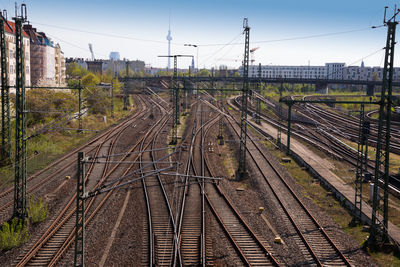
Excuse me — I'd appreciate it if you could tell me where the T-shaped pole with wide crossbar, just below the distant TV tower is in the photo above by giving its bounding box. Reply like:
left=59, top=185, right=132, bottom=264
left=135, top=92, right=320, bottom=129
left=158, top=55, right=193, bottom=145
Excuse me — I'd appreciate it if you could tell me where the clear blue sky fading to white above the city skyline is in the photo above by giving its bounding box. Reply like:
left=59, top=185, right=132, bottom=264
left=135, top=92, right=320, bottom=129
left=0, top=0, right=400, bottom=68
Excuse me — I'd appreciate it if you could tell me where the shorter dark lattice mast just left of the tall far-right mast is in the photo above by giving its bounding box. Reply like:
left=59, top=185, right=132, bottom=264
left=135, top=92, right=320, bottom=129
left=351, top=104, right=369, bottom=225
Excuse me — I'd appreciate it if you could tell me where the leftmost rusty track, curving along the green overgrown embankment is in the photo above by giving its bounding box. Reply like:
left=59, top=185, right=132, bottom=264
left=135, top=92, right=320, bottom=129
left=0, top=96, right=146, bottom=221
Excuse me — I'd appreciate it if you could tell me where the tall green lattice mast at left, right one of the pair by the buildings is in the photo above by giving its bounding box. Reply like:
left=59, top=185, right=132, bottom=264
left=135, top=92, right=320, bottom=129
left=13, top=4, right=27, bottom=220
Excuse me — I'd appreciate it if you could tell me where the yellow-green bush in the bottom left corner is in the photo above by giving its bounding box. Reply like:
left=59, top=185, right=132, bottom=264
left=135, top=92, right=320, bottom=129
left=0, top=218, right=29, bottom=250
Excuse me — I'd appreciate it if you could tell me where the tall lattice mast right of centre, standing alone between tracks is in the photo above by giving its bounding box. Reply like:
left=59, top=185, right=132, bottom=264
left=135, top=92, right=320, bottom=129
left=236, top=18, right=250, bottom=180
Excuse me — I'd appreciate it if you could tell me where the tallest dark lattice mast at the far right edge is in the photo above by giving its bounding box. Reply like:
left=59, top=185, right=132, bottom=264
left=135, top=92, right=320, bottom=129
left=369, top=8, right=399, bottom=245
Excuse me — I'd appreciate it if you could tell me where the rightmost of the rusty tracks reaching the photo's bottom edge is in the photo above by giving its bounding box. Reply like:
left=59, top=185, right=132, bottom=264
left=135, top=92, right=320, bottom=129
left=223, top=103, right=351, bottom=266
